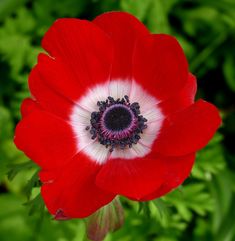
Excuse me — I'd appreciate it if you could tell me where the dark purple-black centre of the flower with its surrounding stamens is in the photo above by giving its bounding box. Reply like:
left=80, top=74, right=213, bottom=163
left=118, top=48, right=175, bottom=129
left=86, top=95, right=147, bottom=152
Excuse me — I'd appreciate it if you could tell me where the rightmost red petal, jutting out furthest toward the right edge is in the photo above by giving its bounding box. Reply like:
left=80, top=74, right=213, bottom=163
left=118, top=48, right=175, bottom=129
left=153, top=100, right=221, bottom=156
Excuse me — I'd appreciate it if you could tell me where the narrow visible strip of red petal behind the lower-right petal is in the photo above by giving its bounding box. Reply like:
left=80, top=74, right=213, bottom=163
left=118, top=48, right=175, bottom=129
left=141, top=154, right=195, bottom=201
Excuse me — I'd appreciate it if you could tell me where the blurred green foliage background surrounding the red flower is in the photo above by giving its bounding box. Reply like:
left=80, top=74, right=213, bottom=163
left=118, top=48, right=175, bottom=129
left=0, top=0, right=235, bottom=241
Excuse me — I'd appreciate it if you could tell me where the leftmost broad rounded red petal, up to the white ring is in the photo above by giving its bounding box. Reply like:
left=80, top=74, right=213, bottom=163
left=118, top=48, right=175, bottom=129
left=14, top=111, right=77, bottom=169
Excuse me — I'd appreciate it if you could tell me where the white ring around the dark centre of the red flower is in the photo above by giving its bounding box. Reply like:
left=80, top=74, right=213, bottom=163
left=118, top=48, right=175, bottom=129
left=70, top=79, right=164, bottom=164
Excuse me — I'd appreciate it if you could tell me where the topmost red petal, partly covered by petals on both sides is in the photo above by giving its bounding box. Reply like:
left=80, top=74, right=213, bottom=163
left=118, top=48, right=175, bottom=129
left=93, top=12, right=149, bottom=79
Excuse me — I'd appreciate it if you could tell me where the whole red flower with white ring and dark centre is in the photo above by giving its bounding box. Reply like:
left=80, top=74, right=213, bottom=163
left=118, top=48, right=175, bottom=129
left=15, top=12, right=221, bottom=219
